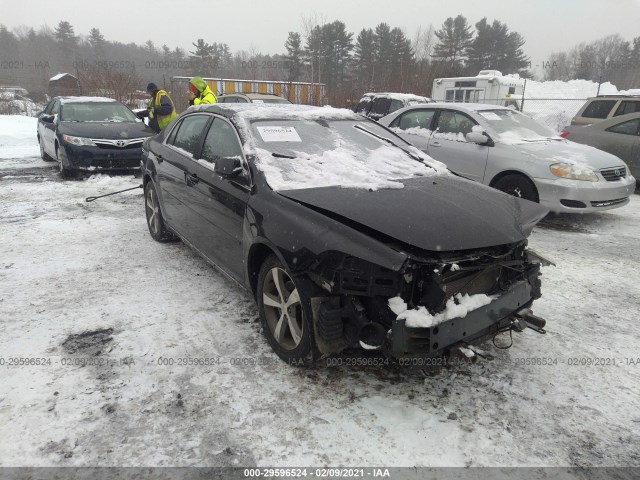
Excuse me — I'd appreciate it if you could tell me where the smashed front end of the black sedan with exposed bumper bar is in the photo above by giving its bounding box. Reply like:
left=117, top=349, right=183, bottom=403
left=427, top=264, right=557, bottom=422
left=308, top=240, right=547, bottom=358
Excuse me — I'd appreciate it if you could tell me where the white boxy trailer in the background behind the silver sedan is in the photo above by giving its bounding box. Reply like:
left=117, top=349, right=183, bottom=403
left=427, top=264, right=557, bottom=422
left=431, top=70, right=525, bottom=110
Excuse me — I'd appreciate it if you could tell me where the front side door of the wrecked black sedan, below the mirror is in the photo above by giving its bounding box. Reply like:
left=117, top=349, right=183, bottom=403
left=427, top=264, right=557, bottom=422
left=187, top=117, right=251, bottom=281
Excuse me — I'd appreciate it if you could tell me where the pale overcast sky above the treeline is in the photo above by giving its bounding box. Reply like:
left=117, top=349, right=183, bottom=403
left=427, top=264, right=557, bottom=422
left=0, top=0, right=640, bottom=70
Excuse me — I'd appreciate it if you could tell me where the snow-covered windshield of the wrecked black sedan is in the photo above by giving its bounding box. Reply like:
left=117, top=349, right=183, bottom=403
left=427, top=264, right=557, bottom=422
left=251, top=119, right=446, bottom=190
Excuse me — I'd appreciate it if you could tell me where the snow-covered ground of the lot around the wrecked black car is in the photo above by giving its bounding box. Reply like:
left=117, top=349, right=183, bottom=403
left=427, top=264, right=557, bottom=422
left=0, top=116, right=640, bottom=466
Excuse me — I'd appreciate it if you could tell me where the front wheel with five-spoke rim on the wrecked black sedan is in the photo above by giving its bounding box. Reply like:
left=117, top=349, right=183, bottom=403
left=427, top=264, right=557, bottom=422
left=258, top=255, right=315, bottom=366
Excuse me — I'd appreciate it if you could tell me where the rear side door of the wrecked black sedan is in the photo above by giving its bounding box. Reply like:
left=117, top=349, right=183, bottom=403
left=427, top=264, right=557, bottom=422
left=152, top=113, right=212, bottom=241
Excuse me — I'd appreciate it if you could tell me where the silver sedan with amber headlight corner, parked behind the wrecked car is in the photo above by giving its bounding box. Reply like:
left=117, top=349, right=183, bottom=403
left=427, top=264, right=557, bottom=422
left=379, top=103, right=636, bottom=213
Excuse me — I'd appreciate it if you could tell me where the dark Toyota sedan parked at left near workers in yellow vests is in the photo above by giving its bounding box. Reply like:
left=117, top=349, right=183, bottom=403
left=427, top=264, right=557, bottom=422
left=38, top=97, right=155, bottom=176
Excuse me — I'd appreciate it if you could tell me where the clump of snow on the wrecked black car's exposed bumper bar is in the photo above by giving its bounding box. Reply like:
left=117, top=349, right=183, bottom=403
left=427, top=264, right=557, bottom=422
left=389, top=293, right=497, bottom=328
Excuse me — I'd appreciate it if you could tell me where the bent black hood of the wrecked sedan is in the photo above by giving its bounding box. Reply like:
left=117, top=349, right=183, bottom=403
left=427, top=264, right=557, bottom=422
left=278, top=176, right=548, bottom=252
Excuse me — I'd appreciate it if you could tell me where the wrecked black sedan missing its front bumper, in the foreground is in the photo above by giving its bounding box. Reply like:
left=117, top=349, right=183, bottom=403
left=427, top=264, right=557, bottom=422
left=142, top=104, right=547, bottom=364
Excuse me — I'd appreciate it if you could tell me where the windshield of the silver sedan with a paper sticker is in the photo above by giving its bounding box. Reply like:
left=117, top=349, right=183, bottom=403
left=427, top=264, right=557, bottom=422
left=478, top=110, right=562, bottom=143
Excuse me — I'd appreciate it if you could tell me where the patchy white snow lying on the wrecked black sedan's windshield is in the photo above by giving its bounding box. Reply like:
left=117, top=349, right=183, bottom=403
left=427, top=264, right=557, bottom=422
left=254, top=145, right=443, bottom=190
